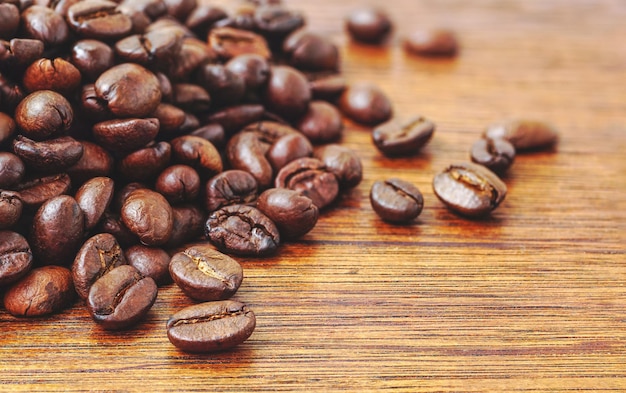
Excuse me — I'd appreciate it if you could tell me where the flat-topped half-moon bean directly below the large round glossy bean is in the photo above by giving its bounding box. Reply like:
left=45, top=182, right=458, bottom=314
left=92, top=117, right=160, bottom=152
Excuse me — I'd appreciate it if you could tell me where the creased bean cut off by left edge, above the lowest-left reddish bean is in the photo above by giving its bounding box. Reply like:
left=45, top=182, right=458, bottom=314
left=0, top=230, right=33, bottom=287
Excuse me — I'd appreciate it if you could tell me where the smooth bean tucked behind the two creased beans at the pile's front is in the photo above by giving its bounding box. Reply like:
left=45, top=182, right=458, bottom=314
left=124, top=244, right=172, bottom=285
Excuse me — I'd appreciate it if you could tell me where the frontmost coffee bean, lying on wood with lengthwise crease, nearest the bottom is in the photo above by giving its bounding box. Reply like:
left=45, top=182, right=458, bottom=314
left=166, top=300, right=256, bottom=353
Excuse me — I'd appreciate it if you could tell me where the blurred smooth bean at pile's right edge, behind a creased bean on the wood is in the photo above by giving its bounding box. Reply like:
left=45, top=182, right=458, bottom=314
left=338, top=82, right=393, bottom=125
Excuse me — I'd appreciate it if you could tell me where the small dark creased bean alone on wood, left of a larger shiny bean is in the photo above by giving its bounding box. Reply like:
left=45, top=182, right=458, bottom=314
left=370, top=178, right=424, bottom=223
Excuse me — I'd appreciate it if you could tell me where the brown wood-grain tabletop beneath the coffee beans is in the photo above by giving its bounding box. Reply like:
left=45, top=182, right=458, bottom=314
left=0, top=0, right=626, bottom=392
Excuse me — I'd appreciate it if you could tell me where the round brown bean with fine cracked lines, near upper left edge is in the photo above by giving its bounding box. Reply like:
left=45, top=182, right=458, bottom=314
left=15, top=90, right=74, bottom=141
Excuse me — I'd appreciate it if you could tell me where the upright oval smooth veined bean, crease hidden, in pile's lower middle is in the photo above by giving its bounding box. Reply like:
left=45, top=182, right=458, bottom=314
left=121, top=189, right=174, bottom=246
